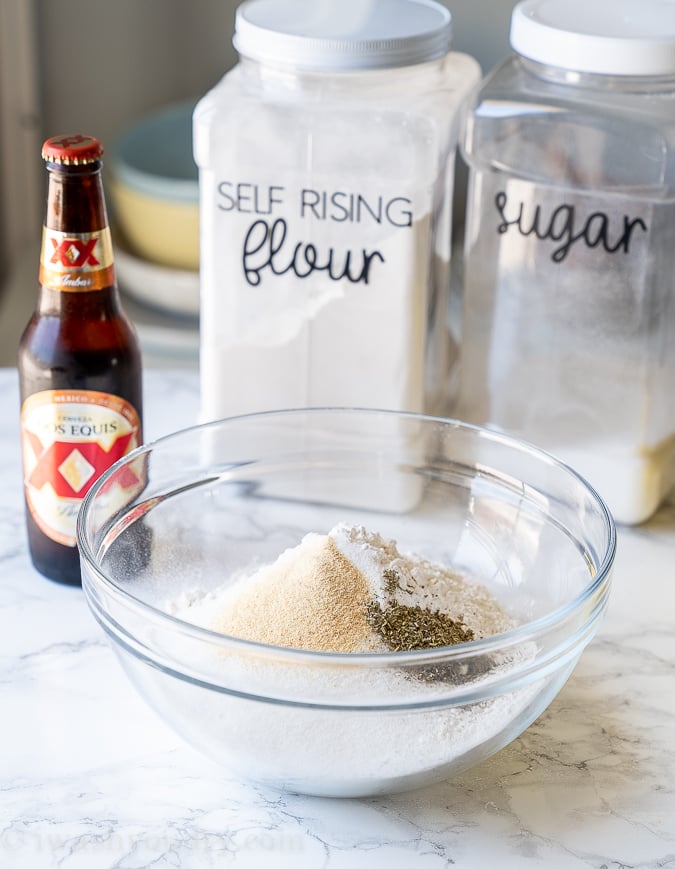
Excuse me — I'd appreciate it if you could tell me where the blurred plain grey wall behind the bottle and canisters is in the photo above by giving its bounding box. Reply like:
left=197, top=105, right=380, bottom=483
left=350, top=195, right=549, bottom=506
left=0, top=0, right=515, bottom=286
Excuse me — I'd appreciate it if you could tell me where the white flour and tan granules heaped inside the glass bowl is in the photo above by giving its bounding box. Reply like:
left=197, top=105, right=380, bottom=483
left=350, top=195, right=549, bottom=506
left=169, top=525, right=544, bottom=796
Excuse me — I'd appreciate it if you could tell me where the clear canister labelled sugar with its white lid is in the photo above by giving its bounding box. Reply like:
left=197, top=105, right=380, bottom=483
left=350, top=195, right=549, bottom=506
left=462, top=0, right=675, bottom=524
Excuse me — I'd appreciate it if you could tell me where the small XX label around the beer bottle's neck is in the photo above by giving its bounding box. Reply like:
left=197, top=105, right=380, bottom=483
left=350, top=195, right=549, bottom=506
left=39, top=226, right=115, bottom=293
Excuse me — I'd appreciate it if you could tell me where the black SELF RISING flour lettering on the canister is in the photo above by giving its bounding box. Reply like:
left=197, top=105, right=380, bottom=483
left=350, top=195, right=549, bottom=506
left=217, top=181, right=413, bottom=287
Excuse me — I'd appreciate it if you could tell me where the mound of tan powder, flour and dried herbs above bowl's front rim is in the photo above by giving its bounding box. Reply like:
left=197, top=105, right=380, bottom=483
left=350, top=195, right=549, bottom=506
left=172, top=523, right=514, bottom=652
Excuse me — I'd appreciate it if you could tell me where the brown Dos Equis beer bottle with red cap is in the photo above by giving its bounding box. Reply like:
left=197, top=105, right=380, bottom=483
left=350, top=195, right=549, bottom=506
left=18, top=135, right=142, bottom=585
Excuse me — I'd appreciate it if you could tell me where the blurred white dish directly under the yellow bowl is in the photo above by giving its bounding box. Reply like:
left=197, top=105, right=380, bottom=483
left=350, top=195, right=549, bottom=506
left=114, top=239, right=199, bottom=317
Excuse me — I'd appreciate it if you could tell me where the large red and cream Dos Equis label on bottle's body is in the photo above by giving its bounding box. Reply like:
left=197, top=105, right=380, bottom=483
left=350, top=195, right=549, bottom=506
left=21, top=389, right=143, bottom=546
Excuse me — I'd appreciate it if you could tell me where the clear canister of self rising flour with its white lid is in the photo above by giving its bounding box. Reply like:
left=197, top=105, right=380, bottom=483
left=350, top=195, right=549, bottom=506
left=194, top=0, right=480, bottom=419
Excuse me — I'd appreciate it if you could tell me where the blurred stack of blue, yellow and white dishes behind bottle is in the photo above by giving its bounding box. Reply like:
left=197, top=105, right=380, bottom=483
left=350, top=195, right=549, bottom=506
left=106, top=101, right=199, bottom=362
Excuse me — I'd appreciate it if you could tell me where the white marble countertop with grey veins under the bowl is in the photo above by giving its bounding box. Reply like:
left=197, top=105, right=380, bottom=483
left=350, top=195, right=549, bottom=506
left=0, top=368, right=675, bottom=869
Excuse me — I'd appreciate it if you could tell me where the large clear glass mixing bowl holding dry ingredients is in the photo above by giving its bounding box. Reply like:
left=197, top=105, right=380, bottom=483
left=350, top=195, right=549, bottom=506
left=78, top=409, right=616, bottom=796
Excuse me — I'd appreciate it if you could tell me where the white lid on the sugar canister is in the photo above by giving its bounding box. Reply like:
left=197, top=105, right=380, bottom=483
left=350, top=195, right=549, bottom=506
left=511, top=0, right=675, bottom=76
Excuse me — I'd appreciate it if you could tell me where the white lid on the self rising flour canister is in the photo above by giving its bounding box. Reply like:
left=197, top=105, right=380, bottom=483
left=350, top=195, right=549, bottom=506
left=233, top=0, right=451, bottom=70
